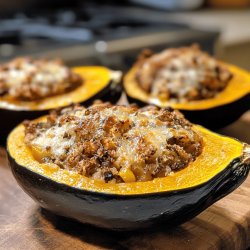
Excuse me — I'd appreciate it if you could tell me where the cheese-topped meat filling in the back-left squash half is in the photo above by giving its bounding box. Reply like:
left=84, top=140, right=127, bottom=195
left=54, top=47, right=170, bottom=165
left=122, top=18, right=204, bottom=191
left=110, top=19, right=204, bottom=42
left=0, top=58, right=83, bottom=101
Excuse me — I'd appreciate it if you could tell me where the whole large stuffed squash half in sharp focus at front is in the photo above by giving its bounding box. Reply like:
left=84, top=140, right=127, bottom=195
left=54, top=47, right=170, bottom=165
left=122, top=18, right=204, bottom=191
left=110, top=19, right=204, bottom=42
left=7, top=103, right=250, bottom=230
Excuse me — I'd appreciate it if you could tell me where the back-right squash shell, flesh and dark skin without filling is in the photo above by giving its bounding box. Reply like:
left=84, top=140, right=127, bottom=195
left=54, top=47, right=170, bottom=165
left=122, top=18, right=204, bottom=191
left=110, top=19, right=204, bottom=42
left=123, top=63, right=250, bottom=129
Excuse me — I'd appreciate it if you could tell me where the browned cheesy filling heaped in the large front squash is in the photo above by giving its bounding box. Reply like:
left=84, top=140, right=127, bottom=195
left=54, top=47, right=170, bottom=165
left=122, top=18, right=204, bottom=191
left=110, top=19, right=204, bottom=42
left=25, top=103, right=203, bottom=183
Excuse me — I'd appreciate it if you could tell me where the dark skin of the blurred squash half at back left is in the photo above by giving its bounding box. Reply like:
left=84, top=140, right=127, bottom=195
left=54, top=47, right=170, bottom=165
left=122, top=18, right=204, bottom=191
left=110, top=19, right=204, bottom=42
left=0, top=80, right=122, bottom=145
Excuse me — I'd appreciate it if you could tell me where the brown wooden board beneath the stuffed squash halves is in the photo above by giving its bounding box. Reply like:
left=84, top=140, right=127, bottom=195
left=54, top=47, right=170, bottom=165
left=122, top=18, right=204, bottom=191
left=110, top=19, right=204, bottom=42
left=0, top=112, right=250, bottom=250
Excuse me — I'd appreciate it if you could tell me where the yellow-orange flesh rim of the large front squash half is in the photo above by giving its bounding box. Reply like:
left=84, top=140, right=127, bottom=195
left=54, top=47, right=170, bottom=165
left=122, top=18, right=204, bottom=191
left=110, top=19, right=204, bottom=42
left=7, top=120, right=244, bottom=195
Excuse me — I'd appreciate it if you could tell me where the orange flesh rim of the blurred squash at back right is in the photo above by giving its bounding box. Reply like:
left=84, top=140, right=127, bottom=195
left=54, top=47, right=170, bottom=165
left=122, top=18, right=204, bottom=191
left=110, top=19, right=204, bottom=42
left=124, top=63, right=250, bottom=110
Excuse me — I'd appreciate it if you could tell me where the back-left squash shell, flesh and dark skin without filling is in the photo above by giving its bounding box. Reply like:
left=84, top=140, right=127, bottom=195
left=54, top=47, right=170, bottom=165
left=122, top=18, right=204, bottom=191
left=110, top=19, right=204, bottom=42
left=0, top=66, right=121, bottom=143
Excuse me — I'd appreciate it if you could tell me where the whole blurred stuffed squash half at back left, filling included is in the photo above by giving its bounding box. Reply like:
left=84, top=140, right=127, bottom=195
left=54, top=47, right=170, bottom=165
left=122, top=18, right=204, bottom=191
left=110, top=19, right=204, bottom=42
left=0, top=58, right=121, bottom=141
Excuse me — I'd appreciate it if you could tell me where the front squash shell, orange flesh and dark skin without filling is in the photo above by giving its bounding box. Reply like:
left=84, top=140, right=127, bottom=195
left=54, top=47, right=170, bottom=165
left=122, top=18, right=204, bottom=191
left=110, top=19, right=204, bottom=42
left=7, top=118, right=250, bottom=230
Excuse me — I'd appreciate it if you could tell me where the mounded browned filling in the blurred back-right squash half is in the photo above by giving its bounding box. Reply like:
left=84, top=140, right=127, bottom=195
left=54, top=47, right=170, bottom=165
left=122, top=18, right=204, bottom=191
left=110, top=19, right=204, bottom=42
left=136, top=45, right=232, bottom=102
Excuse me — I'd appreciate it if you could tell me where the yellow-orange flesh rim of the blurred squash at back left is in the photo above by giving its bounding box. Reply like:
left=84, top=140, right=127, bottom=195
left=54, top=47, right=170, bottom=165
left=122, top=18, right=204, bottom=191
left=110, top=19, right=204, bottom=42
left=0, top=66, right=111, bottom=110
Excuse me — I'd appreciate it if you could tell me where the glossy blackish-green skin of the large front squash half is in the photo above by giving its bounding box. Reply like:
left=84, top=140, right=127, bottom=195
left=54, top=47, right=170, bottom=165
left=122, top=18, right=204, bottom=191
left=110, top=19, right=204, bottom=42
left=8, top=147, right=250, bottom=231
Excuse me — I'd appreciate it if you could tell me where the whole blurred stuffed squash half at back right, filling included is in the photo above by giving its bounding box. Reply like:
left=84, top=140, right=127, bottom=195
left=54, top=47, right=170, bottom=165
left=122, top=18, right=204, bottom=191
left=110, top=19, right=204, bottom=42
left=124, top=45, right=250, bottom=129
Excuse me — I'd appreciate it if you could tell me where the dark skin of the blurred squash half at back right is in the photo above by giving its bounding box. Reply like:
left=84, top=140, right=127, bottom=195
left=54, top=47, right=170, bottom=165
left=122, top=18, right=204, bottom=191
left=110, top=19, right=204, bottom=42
left=127, top=94, right=250, bottom=130
